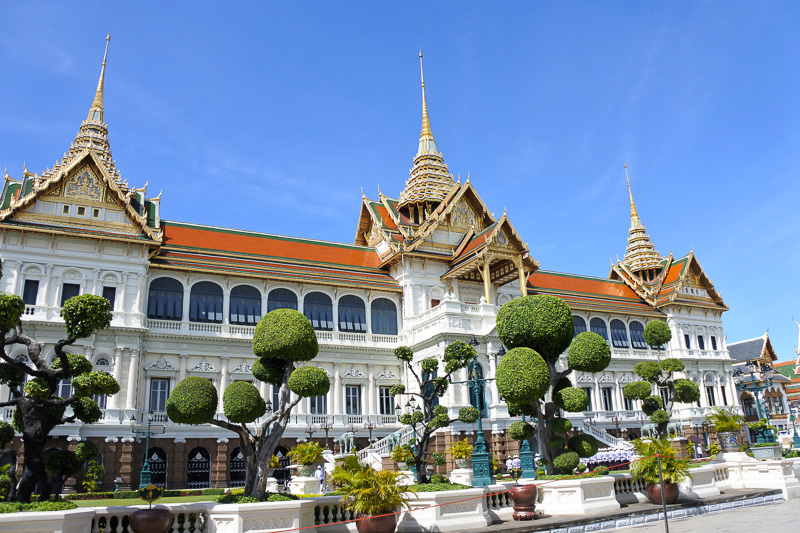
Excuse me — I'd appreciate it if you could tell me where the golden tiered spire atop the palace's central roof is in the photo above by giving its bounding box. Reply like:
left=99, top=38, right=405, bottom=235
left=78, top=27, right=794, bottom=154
left=398, top=51, right=454, bottom=209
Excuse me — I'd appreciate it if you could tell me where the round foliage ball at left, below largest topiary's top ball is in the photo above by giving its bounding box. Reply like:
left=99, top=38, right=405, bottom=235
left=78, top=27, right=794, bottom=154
left=496, top=344, right=550, bottom=404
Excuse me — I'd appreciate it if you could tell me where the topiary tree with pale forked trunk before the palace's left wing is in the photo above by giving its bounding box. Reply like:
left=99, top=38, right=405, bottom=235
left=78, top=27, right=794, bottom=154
left=167, top=309, right=330, bottom=499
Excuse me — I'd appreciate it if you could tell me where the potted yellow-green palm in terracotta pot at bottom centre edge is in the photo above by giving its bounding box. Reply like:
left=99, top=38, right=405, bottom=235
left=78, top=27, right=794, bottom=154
left=333, top=454, right=414, bottom=533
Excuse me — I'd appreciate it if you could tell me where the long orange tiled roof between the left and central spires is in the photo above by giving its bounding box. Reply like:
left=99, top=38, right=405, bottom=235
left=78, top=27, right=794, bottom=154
left=150, top=221, right=401, bottom=291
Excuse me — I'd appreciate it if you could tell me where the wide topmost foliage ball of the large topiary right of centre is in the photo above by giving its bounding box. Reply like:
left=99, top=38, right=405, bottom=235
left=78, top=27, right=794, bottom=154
left=497, top=295, right=575, bottom=361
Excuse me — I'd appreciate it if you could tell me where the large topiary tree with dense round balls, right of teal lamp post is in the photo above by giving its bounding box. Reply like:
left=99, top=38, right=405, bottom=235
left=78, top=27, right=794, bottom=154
left=496, top=295, right=611, bottom=474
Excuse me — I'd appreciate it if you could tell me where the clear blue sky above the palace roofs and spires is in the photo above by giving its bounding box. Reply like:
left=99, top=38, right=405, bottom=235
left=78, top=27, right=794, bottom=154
left=0, top=1, right=800, bottom=360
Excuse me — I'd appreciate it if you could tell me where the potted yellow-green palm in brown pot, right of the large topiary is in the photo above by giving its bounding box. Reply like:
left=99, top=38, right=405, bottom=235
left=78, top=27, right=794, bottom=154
left=631, top=438, right=691, bottom=503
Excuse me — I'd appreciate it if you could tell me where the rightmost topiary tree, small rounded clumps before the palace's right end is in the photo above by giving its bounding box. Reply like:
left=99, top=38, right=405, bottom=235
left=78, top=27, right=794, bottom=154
left=622, top=320, right=700, bottom=438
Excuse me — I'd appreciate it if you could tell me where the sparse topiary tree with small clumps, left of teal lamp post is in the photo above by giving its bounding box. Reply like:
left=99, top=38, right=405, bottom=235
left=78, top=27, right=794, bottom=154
left=389, top=341, right=480, bottom=483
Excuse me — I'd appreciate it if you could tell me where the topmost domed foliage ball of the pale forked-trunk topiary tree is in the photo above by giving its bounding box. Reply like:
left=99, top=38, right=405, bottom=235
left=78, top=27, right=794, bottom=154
left=253, top=309, right=319, bottom=361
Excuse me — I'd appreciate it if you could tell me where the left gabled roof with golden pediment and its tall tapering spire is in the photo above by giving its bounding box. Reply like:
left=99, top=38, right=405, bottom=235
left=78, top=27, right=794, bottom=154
left=0, top=35, right=161, bottom=243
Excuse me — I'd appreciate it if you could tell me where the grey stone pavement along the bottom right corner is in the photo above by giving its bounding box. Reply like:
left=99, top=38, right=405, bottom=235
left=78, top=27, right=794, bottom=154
left=462, top=489, right=788, bottom=533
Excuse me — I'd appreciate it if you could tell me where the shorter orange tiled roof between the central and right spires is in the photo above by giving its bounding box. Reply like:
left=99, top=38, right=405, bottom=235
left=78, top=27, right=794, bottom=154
left=528, top=270, right=664, bottom=318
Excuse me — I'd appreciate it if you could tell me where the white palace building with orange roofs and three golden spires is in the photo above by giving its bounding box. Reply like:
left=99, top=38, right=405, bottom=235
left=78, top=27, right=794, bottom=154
left=0, top=42, right=737, bottom=490
